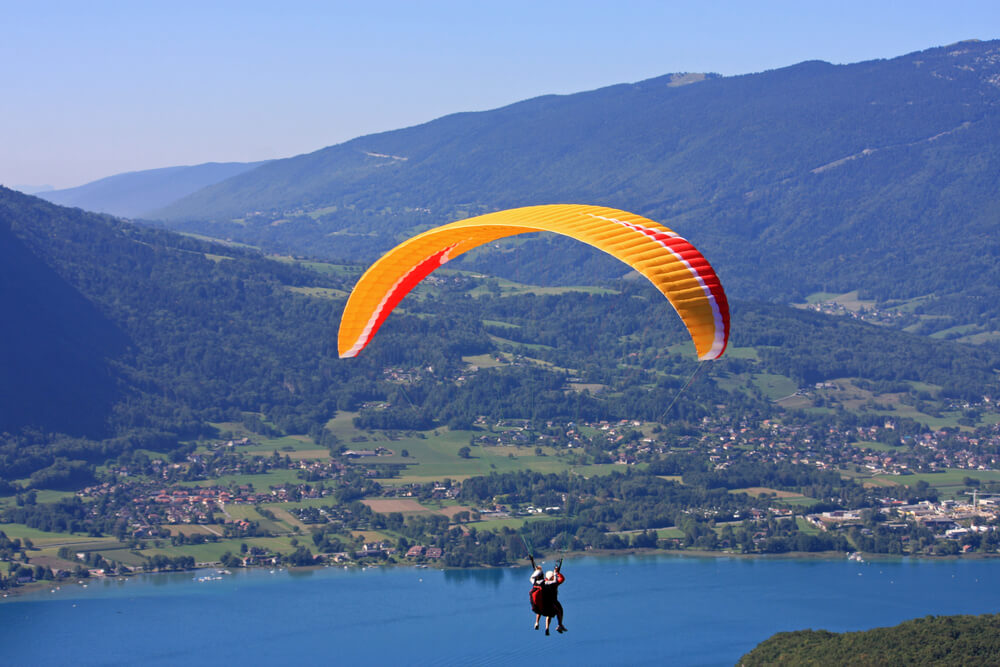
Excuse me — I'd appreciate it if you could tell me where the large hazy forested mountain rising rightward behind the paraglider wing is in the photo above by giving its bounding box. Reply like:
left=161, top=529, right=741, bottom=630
left=150, top=41, right=1000, bottom=330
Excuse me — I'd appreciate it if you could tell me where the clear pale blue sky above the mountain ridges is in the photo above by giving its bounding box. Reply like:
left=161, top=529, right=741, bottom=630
left=0, top=0, right=1000, bottom=188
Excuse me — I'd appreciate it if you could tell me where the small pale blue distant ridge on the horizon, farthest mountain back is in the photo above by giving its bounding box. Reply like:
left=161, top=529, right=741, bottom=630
left=38, top=162, right=264, bottom=218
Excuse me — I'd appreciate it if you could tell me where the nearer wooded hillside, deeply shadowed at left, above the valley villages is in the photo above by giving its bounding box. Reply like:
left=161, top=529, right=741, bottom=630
left=0, top=189, right=998, bottom=488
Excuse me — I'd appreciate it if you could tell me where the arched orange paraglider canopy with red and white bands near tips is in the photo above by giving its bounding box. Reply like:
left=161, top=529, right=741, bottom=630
left=338, top=204, right=729, bottom=361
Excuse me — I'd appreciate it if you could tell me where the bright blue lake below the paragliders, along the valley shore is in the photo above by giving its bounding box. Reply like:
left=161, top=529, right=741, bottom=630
left=0, top=556, right=1000, bottom=665
